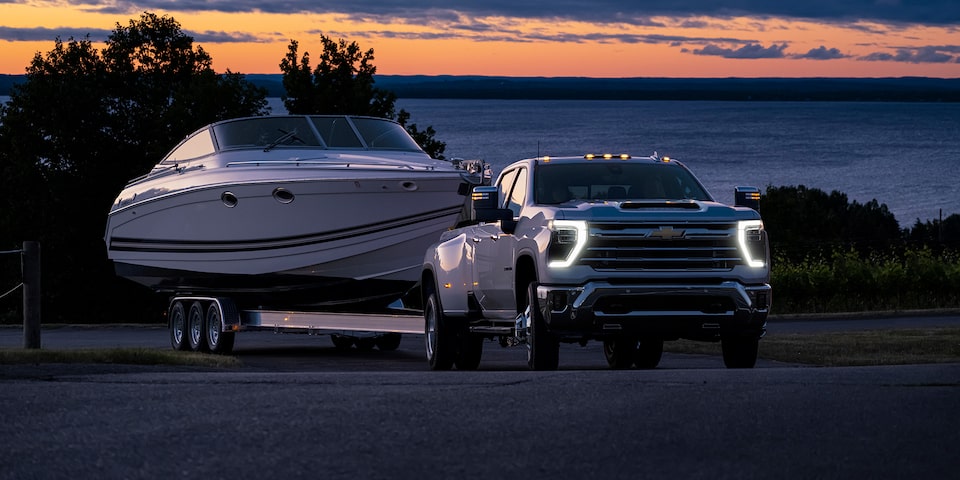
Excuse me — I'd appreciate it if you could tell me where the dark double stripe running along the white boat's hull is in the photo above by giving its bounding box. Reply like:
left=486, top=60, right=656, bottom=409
left=110, top=205, right=462, bottom=253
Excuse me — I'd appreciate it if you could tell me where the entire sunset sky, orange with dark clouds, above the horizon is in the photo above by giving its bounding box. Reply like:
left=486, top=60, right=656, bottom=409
left=0, top=0, right=960, bottom=78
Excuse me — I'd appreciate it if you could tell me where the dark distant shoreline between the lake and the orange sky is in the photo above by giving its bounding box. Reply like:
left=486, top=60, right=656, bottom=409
left=0, top=74, right=960, bottom=102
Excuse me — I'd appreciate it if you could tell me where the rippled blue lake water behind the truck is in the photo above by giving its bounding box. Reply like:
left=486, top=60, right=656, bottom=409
left=0, top=97, right=960, bottom=227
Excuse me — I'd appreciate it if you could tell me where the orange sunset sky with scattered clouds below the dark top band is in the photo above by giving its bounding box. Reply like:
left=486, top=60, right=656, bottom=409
left=0, top=3, right=960, bottom=77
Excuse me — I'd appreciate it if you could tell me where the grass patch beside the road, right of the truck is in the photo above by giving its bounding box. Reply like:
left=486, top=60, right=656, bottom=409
left=664, top=327, right=960, bottom=367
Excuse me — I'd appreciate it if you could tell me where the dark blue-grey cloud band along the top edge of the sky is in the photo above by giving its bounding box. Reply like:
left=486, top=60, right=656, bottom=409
left=70, top=0, right=960, bottom=25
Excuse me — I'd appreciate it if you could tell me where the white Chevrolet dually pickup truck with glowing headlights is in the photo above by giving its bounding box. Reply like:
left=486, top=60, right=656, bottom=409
left=421, top=154, right=772, bottom=370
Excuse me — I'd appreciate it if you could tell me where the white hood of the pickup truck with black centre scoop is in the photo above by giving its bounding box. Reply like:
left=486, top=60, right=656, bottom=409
left=555, top=200, right=760, bottom=222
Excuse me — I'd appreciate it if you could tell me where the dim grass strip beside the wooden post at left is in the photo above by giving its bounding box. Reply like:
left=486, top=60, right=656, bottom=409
left=0, top=348, right=241, bottom=368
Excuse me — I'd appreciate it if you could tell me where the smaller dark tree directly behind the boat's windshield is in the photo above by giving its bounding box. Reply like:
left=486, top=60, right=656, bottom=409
left=280, top=35, right=447, bottom=159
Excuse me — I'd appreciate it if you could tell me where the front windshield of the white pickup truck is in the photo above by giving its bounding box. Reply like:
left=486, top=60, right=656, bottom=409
left=535, top=162, right=712, bottom=204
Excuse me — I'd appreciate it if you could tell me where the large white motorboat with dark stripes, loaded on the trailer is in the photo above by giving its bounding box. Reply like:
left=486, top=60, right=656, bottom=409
left=104, top=115, right=489, bottom=316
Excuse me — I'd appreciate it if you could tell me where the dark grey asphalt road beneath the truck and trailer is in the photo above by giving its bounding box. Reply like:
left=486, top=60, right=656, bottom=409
left=0, top=318, right=960, bottom=479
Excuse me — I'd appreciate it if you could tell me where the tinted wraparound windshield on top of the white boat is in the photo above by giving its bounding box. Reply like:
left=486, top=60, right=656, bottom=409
left=213, top=115, right=422, bottom=152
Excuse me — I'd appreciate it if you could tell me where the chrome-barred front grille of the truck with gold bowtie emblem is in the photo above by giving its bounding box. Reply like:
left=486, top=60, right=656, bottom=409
left=579, top=222, right=743, bottom=271
